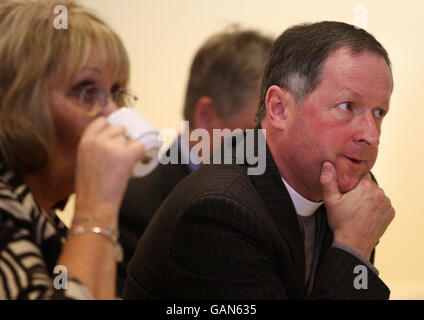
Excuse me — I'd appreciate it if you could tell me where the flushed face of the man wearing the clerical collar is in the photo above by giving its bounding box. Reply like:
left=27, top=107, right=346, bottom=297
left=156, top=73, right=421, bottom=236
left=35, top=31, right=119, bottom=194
left=283, top=47, right=392, bottom=198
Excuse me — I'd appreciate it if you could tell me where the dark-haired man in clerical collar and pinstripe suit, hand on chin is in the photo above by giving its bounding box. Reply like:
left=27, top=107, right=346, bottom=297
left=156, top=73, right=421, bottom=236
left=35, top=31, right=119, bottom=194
left=123, top=22, right=394, bottom=299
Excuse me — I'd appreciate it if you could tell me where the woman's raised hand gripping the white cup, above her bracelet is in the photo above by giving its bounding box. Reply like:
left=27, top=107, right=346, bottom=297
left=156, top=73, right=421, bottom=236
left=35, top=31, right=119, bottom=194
left=74, top=117, right=144, bottom=228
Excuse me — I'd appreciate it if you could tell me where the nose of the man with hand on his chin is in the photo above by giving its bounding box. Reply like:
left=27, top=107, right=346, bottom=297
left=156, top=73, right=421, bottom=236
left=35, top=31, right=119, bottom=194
left=354, top=112, right=380, bottom=146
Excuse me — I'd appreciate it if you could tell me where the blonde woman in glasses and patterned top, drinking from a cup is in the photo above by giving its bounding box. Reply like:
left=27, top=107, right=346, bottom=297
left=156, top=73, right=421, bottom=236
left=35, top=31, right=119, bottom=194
left=0, top=0, right=144, bottom=299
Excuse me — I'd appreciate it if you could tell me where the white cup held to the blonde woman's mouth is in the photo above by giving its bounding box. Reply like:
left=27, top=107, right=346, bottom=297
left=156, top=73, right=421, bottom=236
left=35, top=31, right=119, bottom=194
left=107, top=107, right=161, bottom=177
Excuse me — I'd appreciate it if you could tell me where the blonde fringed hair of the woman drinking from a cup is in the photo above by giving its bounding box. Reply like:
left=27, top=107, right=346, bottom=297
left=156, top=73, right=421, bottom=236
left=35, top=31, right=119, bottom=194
left=0, top=0, right=129, bottom=174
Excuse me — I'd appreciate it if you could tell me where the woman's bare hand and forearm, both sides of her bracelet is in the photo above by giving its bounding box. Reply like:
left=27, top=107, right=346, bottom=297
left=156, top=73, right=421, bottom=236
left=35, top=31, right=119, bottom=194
left=58, top=117, right=144, bottom=299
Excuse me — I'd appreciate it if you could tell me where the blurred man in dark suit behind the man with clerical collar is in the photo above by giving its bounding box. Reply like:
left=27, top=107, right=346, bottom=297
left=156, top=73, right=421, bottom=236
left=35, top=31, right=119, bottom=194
left=118, top=28, right=273, bottom=293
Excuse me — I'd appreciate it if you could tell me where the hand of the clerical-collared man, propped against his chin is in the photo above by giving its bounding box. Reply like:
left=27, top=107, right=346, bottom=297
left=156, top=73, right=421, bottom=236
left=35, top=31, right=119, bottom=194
left=320, top=161, right=395, bottom=259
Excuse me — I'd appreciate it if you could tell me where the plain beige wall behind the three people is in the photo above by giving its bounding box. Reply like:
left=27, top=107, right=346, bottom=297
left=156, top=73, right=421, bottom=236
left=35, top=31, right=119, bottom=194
left=68, top=0, right=424, bottom=299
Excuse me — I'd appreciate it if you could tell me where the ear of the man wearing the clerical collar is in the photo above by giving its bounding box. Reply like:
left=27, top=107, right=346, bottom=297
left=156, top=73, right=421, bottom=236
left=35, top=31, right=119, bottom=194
left=265, top=85, right=292, bottom=130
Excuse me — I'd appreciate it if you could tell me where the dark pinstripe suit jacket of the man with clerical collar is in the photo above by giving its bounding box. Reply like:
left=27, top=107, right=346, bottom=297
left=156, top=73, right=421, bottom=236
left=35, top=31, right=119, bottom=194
left=123, top=130, right=390, bottom=299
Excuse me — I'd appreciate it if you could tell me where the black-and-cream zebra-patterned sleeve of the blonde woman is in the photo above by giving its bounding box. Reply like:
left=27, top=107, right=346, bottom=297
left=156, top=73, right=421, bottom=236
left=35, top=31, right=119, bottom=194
left=0, top=208, right=92, bottom=300
